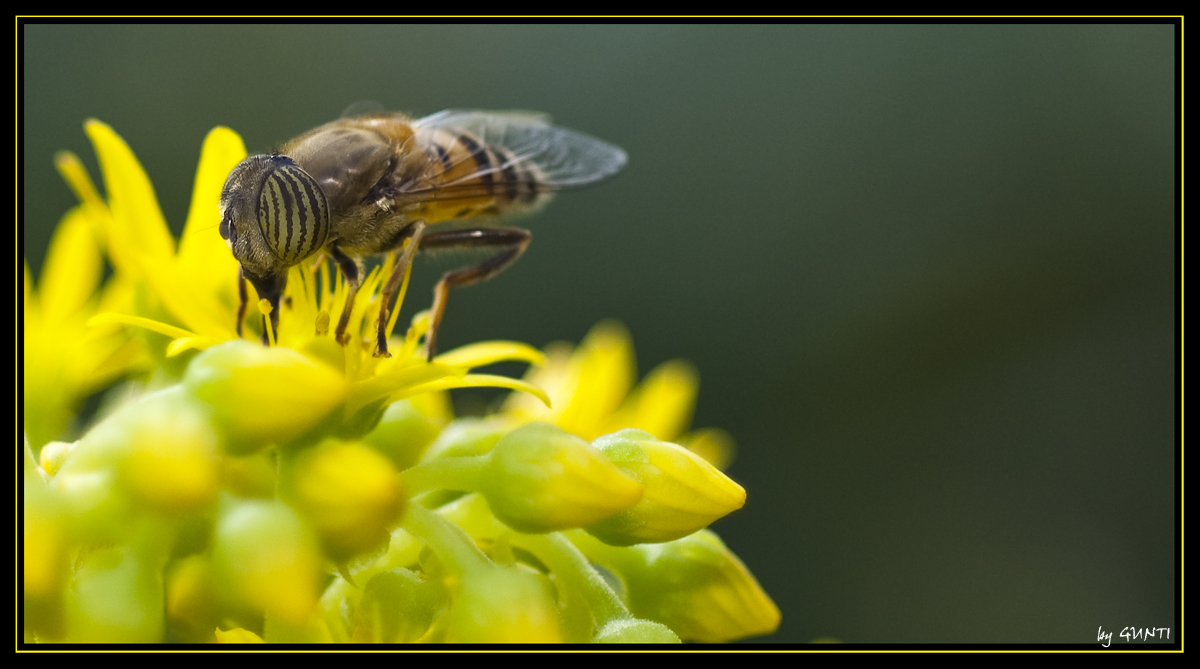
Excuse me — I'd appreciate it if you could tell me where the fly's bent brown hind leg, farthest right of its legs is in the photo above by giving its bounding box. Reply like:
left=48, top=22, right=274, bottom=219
left=421, top=228, right=533, bottom=360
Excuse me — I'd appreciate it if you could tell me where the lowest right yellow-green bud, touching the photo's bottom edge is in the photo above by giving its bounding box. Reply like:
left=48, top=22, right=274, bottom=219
left=571, top=530, right=780, bottom=643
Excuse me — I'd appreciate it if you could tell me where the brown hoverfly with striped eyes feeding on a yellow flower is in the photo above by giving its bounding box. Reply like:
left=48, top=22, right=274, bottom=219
left=220, top=110, right=626, bottom=360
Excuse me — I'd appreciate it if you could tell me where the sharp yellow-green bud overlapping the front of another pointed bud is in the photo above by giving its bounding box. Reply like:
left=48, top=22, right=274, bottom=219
left=479, top=423, right=642, bottom=532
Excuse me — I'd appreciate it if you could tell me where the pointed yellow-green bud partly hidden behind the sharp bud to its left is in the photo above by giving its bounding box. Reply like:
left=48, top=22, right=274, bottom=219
left=587, top=429, right=746, bottom=546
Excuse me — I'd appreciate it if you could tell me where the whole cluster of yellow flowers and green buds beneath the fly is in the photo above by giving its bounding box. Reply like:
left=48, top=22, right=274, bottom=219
left=23, top=121, right=779, bottom=643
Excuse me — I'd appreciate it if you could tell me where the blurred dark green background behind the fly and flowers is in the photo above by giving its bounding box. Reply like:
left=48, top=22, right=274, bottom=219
left=19, top=25, right=1181, bottom=643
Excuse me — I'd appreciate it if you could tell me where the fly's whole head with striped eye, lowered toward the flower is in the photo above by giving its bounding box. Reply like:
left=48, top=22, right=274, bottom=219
left=221, top=155, right=330, bottom=277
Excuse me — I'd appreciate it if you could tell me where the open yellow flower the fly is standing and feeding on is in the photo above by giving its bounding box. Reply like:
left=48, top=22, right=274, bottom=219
left=49, top=120, right=547, bottom=431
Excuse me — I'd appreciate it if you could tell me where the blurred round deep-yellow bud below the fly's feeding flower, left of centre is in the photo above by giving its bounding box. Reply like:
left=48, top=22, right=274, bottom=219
left=292, top=441, right=404, bottom=561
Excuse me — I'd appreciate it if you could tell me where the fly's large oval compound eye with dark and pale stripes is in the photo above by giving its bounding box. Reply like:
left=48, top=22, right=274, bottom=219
left=258, top=156, right=329, bottom=265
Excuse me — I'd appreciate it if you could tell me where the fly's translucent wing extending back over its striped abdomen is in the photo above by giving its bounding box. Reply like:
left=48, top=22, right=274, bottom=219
left=413, top=109, right=628, bottom=189
